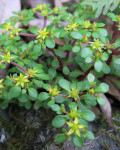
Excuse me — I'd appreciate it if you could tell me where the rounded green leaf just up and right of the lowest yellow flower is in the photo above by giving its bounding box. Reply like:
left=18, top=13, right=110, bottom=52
left=82, top=110, right=95, bottom=121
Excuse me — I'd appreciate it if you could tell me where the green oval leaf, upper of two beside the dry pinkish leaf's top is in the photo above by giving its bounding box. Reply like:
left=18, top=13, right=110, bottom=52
left=95, top=83, right=109, bottom=93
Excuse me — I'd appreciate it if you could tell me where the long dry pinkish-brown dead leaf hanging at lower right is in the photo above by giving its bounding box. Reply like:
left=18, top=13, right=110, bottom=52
left=99, top=93, right=116, bottom=131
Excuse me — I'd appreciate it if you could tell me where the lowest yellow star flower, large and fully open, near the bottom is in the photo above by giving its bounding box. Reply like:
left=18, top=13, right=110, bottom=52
left=66, top=118, right=85, bottom=137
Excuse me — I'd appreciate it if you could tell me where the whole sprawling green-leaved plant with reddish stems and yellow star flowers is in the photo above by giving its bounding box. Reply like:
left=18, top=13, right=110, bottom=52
left=0, top=3, right=120, bottom=147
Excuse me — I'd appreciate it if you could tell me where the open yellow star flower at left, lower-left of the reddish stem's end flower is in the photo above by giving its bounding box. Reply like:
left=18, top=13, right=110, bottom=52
left=14, top=73, right=29, bottom=87
